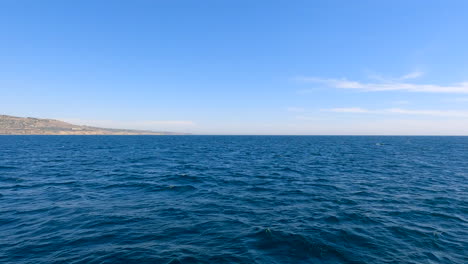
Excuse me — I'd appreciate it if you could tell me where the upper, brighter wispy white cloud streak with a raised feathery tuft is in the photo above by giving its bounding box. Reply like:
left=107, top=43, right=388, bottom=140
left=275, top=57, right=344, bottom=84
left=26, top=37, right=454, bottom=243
left=295, top=72, right=468, bottom=94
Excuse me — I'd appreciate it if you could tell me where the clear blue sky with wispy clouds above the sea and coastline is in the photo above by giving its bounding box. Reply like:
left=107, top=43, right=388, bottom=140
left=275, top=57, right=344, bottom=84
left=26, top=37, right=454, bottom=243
left=0, top=0, right=468, bottom=135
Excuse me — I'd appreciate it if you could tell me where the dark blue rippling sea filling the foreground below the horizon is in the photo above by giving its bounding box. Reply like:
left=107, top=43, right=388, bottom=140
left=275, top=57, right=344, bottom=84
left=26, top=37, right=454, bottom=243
left=0, top=136, right=468, bottom=264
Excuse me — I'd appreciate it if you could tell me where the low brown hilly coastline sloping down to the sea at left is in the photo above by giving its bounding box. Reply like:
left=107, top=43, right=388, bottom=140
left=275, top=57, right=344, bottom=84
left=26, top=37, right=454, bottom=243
left=0, top=115, right=186, bottom=135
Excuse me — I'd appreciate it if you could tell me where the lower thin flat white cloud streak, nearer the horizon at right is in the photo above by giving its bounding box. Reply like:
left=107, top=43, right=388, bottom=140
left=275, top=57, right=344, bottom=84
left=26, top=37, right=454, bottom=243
left=321, top=107, right=468, bottom=117
